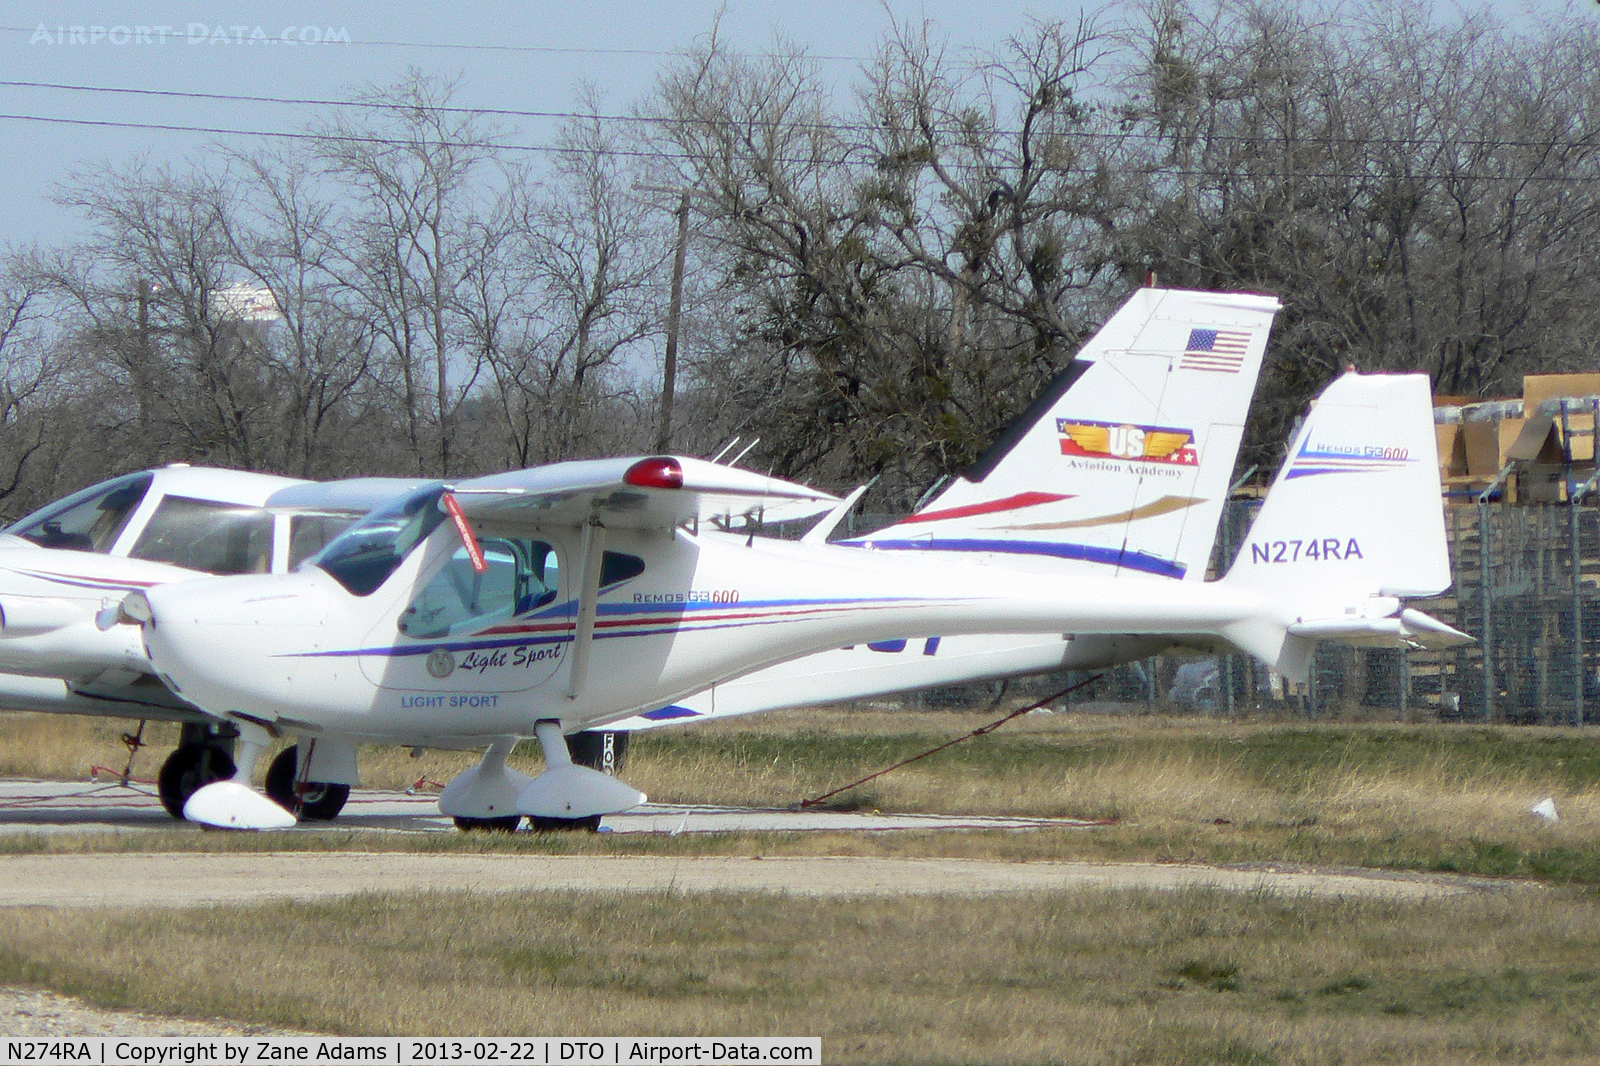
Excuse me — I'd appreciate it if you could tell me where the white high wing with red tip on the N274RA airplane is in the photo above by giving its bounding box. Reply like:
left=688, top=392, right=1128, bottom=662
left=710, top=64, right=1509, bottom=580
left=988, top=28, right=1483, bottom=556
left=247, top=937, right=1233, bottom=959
left=453, top=456, right=838, bottom=528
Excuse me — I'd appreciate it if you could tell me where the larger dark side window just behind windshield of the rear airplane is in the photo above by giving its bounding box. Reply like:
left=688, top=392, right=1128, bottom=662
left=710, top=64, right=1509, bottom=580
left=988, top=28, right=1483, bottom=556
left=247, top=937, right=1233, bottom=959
left=128, top=496, right=272, bottom=573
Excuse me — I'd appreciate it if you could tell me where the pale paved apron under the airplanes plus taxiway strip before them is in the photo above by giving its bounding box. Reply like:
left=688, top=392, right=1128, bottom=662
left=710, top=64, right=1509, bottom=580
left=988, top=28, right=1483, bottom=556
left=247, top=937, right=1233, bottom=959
left=0, top=781, right=1514, bottom=908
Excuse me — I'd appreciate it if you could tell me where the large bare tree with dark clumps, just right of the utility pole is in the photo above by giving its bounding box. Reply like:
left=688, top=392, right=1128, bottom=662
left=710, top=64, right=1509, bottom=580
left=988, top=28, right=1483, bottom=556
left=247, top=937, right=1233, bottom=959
left=646, top=22, right=1110, bottom=482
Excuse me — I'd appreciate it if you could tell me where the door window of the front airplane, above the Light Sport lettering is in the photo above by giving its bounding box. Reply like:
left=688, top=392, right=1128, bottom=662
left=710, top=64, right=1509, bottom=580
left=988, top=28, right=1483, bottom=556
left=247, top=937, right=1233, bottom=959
left=398, top=538, right=560, bottom=640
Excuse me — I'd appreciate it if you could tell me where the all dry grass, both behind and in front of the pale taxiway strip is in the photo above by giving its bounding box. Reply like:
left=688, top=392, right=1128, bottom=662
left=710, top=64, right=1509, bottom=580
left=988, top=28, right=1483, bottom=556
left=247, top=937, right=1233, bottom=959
left=0, top=711, right=1600, bottom=1064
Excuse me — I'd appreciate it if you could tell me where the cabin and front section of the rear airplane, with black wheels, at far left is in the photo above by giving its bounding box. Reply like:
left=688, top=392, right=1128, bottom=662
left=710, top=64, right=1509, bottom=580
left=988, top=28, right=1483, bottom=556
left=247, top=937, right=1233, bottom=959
left=0, top=464, right=426, bottom=816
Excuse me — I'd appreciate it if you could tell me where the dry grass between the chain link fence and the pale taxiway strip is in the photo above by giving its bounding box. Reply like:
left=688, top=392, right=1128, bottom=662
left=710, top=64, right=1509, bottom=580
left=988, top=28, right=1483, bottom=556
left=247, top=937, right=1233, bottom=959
left=0, top=711, right=1600, bottom=885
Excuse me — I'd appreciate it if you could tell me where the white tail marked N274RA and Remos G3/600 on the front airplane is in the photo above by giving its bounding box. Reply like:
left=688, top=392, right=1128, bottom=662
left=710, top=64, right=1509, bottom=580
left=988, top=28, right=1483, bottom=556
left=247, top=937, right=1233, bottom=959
left=1224, top=371, right=1470, bottom=680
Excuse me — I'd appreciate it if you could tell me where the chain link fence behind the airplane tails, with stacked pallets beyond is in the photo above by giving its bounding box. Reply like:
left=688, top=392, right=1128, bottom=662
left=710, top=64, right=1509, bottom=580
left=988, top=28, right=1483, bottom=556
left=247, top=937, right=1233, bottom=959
left=846, top=498, right=1600, bottom=725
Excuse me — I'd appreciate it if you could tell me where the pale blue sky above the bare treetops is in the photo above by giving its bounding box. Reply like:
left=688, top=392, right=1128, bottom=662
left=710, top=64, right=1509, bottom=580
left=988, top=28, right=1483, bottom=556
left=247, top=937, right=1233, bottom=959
left=0, top=0, right=1600, bottom=245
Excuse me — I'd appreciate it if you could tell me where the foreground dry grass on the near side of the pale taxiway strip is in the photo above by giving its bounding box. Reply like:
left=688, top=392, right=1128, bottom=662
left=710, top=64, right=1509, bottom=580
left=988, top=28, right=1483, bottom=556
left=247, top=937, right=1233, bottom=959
left=0, top=892, right=1600, bottom=1064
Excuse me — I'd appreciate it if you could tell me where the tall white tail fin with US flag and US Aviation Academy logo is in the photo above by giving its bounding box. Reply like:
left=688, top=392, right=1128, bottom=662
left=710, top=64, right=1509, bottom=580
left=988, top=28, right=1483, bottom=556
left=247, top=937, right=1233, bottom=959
left=853, top=288, right=1280, bottom=579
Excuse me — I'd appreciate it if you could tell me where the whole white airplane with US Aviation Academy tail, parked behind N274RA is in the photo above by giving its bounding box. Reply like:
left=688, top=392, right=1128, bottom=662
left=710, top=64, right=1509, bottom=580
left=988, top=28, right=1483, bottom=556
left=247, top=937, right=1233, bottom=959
left=0, top=281, right=1278, bottom=818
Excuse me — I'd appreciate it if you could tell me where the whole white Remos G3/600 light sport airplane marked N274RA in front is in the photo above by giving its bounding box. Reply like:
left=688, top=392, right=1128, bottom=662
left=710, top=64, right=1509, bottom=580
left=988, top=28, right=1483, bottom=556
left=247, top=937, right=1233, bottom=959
left=120, top=373, right=1470, bottom=828
